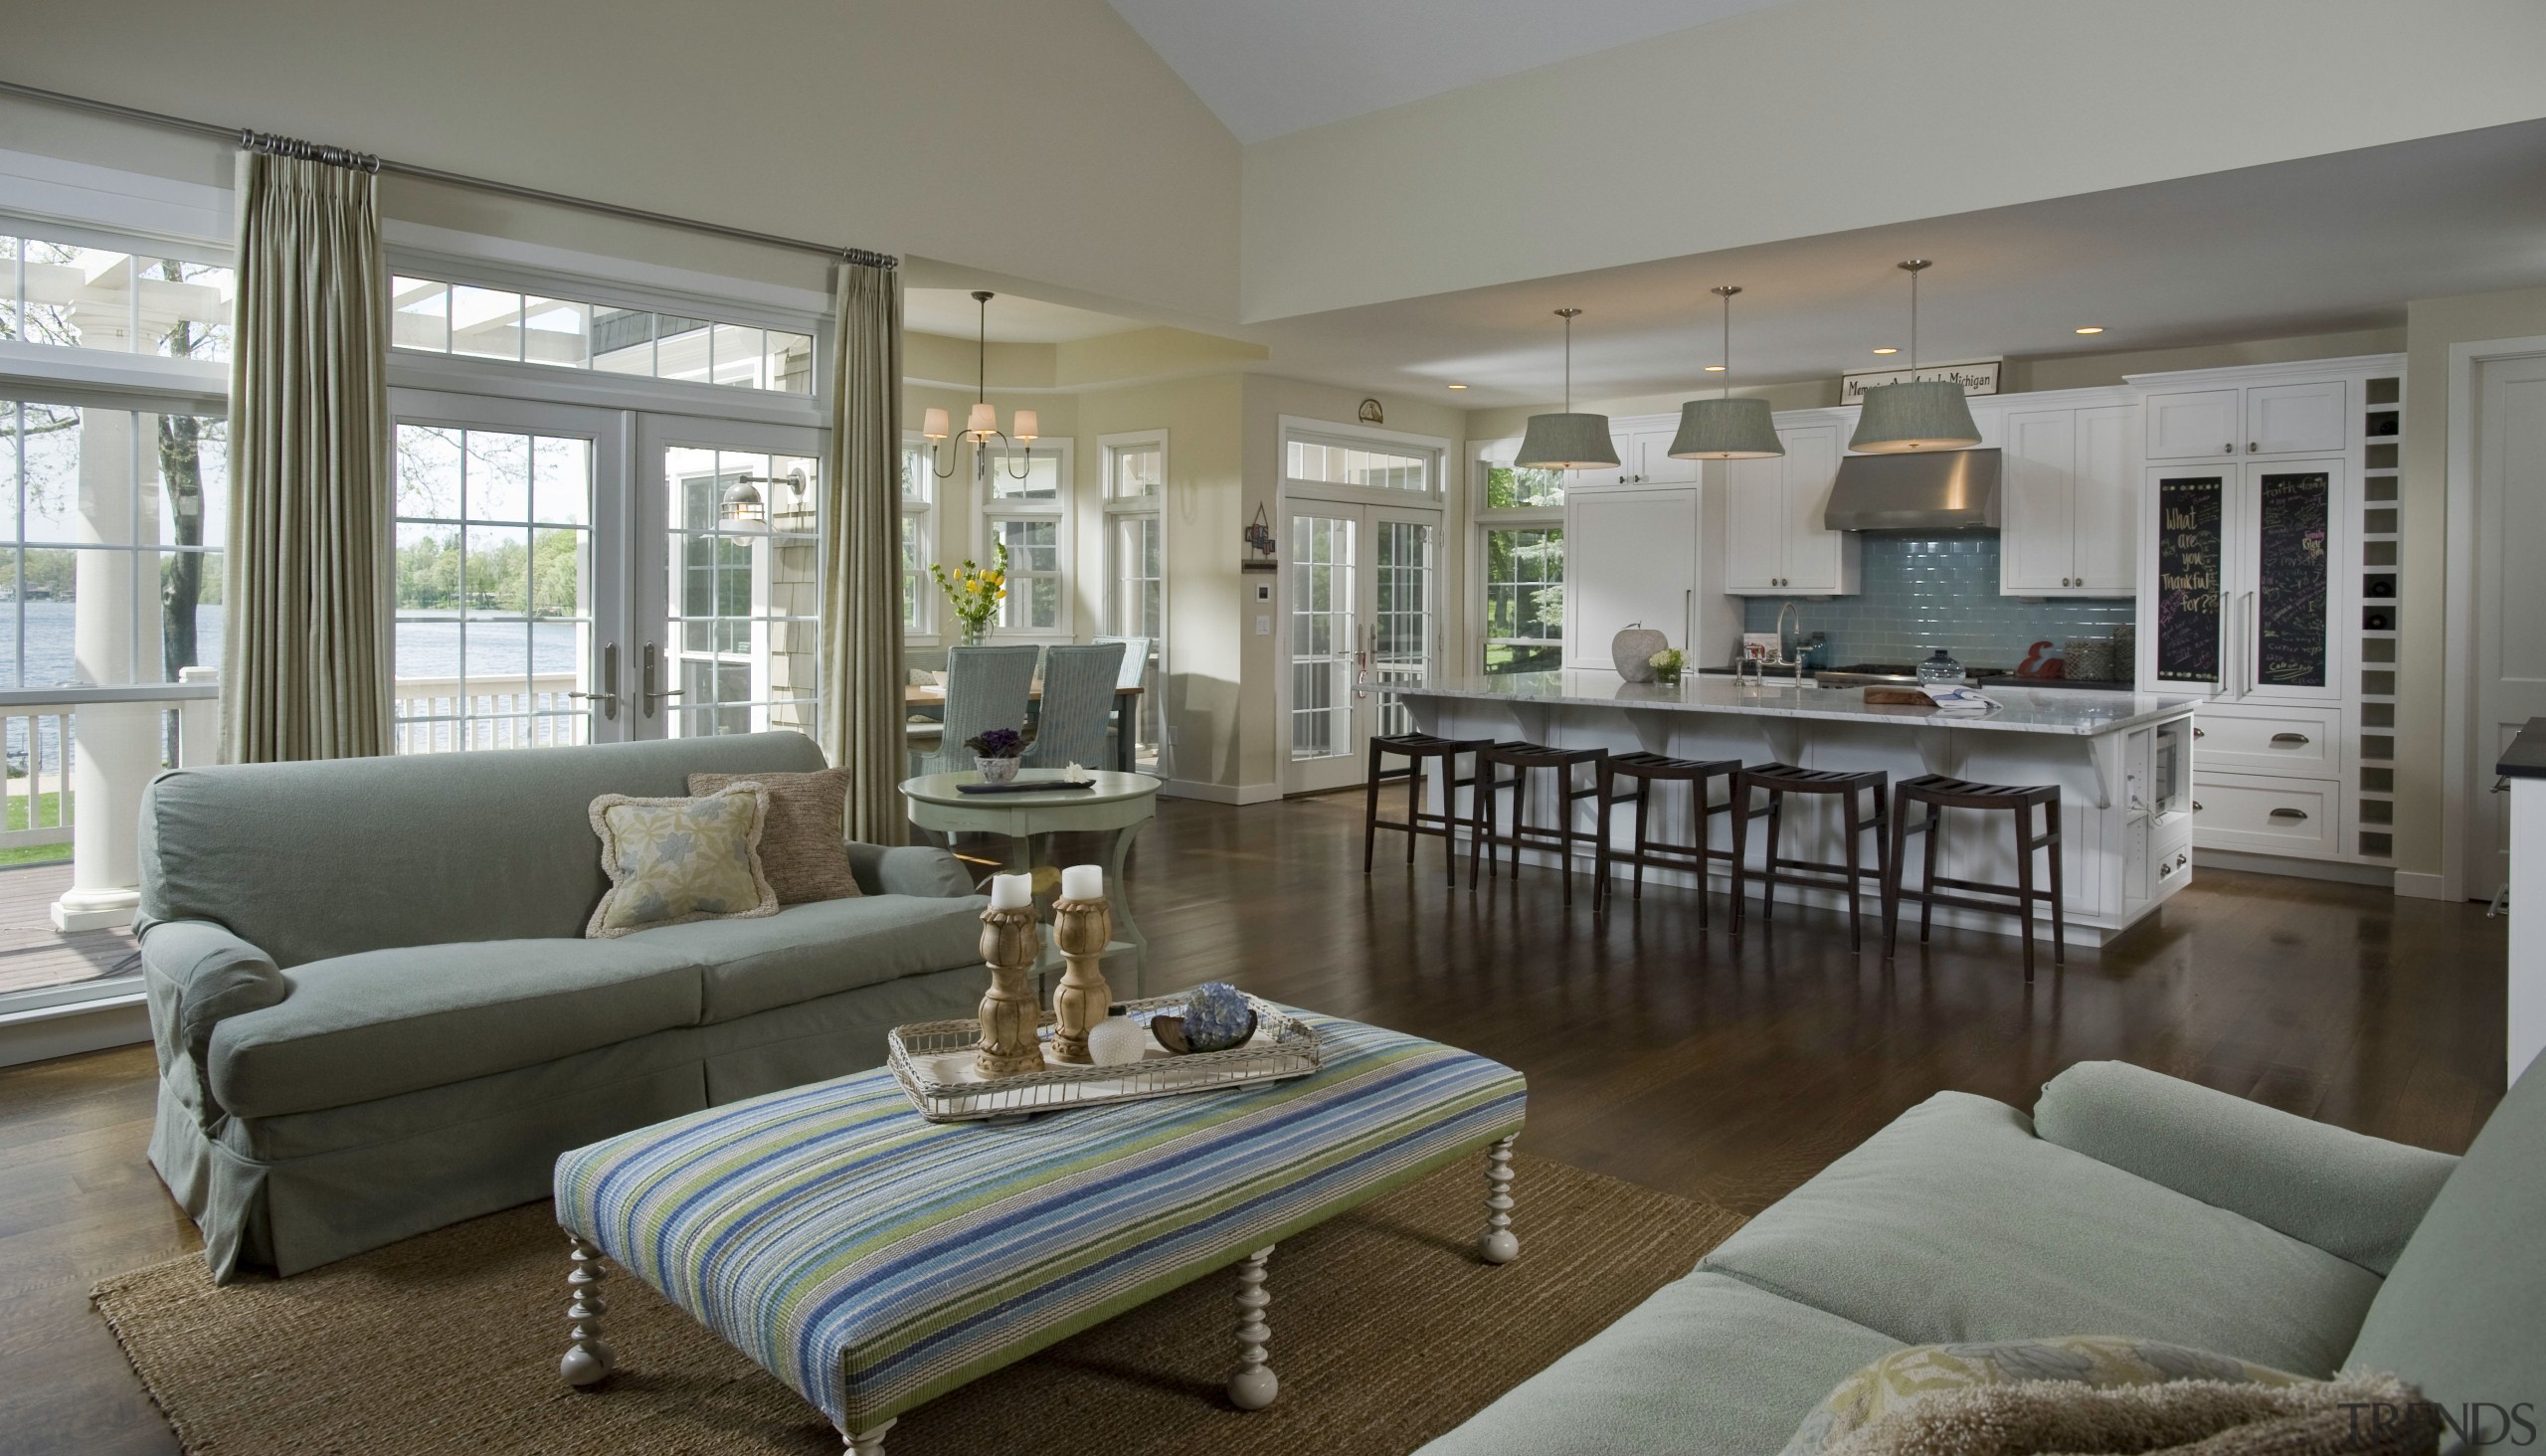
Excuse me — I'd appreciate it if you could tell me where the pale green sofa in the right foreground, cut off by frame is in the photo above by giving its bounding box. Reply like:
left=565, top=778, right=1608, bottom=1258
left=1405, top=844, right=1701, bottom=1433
left=1418, top=1061, right=2546, bottom=1456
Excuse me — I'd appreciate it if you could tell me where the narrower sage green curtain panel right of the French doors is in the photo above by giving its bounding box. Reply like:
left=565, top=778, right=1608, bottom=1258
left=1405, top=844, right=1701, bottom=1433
left=822, top=263, right=911, bottom=845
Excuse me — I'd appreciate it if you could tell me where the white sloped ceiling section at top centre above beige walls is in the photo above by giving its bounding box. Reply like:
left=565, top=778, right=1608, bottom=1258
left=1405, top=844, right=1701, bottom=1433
left=1113, top=0, right=1774, bottom=142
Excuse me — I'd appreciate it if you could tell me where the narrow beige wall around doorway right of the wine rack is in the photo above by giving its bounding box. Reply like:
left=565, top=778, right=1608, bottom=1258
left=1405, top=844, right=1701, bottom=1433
left=2396, top=287, right=2546, bottom=893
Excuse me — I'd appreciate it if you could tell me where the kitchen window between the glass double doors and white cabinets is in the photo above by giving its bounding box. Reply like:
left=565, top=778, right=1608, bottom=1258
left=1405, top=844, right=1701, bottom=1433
left=1472, top=441, right=1565, bottom=672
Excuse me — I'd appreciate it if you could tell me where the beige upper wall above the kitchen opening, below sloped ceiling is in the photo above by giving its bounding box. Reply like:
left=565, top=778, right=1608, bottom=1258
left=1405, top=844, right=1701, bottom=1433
left=1242, top=0, right=2546, bottom=320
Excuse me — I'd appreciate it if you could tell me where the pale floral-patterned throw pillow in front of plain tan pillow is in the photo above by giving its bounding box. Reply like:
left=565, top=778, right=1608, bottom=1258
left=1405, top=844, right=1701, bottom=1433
left=583, top=782, right=779, bottom=939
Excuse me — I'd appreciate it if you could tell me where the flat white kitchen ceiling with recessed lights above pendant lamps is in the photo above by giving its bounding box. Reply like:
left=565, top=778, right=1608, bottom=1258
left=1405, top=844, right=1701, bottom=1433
left=1240, top=122, right=2546, bottom=408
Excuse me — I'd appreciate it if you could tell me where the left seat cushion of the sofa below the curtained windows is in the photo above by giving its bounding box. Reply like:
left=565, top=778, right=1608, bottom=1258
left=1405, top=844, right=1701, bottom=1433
left=211, top=937, right=700, bottom=1118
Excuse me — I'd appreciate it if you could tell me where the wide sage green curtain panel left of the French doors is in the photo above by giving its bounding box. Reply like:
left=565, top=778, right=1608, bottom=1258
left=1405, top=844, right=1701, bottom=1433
left=222, top=153, right=390, bottom=764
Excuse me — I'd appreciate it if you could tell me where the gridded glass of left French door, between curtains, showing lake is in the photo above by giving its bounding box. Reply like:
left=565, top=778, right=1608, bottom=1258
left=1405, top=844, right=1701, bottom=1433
left=392, top=415, right=593, bottom=754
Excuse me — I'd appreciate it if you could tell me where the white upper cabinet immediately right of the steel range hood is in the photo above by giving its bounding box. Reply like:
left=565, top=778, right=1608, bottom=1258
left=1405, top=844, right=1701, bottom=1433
left=1999, top=405, right=2138, bottom=596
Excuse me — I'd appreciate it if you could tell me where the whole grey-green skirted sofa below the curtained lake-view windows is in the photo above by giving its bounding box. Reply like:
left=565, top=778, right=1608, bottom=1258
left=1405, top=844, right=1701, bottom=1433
left=137, top=733, right=986, bottom=1280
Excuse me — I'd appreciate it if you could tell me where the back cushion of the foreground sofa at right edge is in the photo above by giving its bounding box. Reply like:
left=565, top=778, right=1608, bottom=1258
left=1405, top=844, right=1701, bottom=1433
left=2350, top=1056, right=2546, bottom=1448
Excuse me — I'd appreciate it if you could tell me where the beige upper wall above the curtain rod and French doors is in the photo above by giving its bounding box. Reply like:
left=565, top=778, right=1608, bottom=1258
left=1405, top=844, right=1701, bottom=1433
left=5, top=0, right=1237, bottom=318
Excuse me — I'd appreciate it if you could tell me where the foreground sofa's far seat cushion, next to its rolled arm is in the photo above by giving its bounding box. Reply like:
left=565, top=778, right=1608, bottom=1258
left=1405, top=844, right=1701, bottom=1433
left=1701, top=1092, right=2378, bottom=1374
